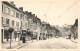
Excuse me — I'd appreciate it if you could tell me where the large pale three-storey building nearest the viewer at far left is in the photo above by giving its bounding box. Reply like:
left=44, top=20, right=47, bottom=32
left=1, top=1, right=21, bottom=42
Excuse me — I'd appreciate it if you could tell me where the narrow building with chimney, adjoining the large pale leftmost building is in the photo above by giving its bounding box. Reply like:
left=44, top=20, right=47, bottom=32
left=19, top=7, right=28, bottom=30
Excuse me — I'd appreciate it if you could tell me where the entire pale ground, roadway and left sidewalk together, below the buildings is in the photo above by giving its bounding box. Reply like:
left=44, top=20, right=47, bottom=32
left=2, top=38, right=77, bottom=49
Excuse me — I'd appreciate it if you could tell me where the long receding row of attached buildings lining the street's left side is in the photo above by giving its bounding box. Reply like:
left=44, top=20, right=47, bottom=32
left=1, top=1, right=55, bottom=42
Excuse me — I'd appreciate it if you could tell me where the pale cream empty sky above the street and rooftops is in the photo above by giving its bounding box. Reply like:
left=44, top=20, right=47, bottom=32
left=2, top=0, right=80, bottom=26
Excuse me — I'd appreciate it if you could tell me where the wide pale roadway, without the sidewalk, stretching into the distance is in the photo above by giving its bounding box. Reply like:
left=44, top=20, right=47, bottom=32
left=19, top=38, right=77, bottom=49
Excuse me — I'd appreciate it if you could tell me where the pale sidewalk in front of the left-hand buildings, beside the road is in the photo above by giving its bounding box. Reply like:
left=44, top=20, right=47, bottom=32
left=2, top=40, right=36, bottom=49
